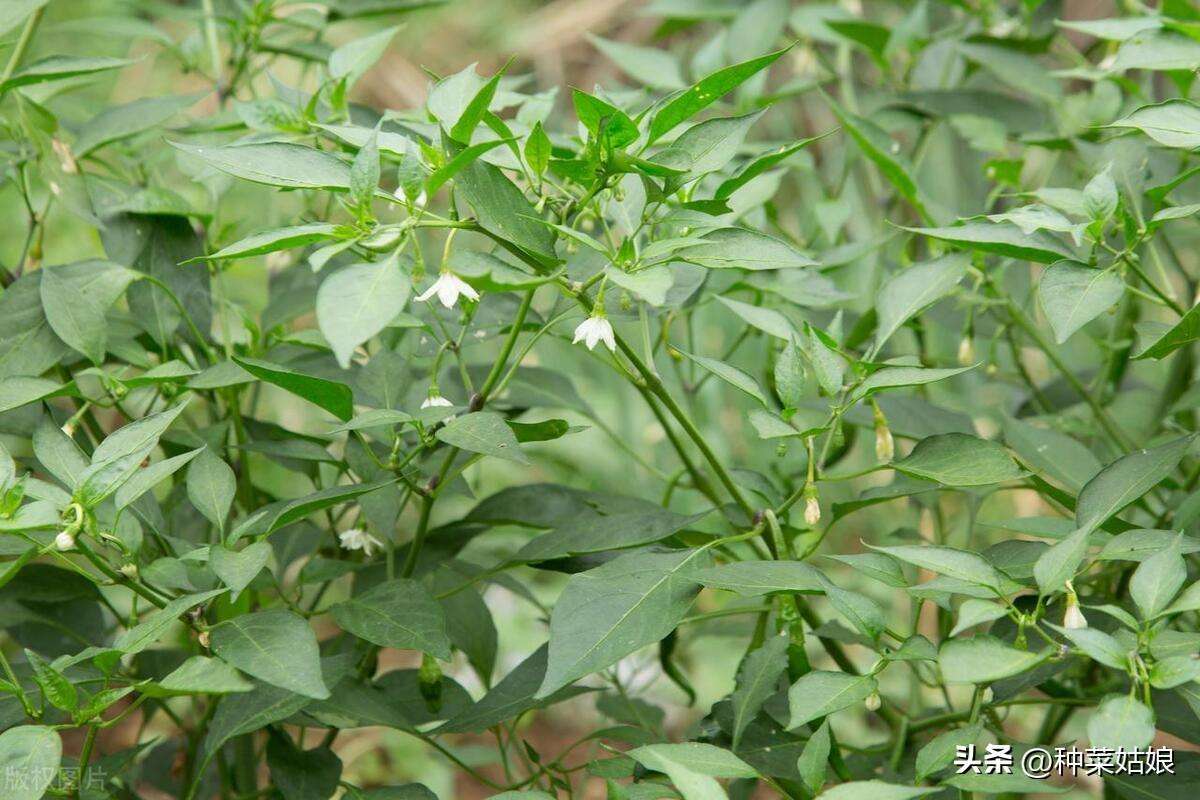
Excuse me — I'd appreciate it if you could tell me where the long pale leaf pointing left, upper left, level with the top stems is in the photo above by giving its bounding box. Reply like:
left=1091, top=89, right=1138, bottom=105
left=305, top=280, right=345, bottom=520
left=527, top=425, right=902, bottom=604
left=170, top=142, right=350, bottom=192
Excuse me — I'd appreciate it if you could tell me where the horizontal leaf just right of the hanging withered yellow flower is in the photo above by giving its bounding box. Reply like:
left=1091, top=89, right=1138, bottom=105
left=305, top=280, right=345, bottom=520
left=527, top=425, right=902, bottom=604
left=892, top=433, right=1025, bottom=486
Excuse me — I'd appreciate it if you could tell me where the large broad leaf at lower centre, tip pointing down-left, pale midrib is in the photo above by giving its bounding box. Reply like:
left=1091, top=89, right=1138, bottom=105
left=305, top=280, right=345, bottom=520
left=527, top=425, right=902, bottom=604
left=538, top=549, right=710, bottom=698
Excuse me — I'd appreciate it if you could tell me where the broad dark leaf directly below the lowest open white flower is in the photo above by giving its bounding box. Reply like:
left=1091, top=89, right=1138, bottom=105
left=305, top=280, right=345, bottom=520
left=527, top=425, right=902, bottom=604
left=330, top=578, right=450, bottom=661
